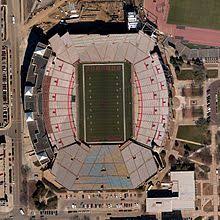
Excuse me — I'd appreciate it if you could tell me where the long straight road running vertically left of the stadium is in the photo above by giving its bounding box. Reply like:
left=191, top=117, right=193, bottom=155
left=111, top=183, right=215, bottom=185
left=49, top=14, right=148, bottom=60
left=0, top=0, right=24, bottom=219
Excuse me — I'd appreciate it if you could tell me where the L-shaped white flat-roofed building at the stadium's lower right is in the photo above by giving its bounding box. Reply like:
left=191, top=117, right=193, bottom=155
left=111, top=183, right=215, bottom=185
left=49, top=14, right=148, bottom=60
left=146, top=171, right=195, bottom=213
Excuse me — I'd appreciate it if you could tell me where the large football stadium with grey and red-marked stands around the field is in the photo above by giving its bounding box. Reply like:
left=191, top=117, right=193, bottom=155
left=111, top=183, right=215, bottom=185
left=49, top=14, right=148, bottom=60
left=24, top=31, right=169, bottom=191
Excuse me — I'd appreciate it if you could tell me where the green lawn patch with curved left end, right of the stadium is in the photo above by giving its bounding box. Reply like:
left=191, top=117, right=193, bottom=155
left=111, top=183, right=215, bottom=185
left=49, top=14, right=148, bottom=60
left=177, top=125, right=210, bottom=144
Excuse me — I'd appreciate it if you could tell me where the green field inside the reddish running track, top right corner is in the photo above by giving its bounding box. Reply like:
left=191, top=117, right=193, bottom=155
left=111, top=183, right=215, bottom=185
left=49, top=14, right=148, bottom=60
left=167, top=0, right=220, bottom=29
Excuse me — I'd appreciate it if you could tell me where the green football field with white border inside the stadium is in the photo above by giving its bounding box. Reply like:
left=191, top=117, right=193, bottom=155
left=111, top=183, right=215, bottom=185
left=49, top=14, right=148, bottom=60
left=78, top=63, right=132, bottom=143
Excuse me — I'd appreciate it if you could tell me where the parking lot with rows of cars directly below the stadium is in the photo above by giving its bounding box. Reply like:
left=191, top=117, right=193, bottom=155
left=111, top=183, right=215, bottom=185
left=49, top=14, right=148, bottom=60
left=58, top=191, right=144, bottom=213
